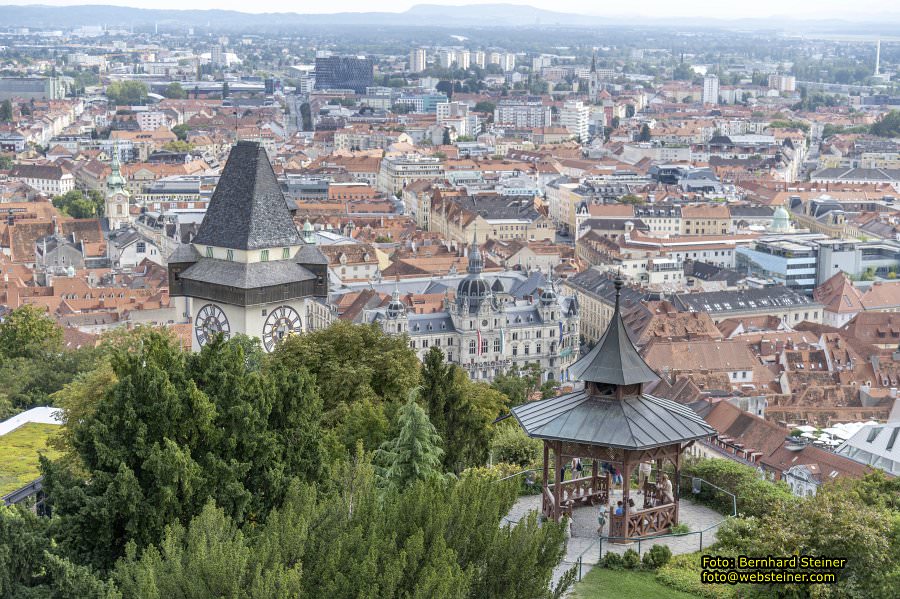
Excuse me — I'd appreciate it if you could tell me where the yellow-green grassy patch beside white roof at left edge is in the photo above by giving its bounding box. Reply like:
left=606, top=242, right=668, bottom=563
left=0, top=422, right=59, bottom=495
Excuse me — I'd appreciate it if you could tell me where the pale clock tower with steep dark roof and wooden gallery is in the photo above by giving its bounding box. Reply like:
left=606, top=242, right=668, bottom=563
left=169, top=141, right=328, bottom=352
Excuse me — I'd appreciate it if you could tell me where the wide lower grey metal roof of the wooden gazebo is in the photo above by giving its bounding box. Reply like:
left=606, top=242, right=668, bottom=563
left=512, top=390, right=716, bottom=449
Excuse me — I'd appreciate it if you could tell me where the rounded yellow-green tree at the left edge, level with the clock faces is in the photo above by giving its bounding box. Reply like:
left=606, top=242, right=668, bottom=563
left=0, top=304, right=62, bottom=361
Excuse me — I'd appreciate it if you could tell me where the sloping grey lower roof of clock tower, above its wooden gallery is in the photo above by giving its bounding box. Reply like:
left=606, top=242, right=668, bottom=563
left=181, top=258, right=316, bottom=289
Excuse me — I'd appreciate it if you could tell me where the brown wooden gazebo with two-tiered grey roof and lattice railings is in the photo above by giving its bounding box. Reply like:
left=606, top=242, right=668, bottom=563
left=512, top=277, right=715, bottom=541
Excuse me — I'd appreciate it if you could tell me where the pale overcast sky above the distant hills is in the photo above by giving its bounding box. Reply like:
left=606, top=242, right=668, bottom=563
left=0, top=0, right=884, bottom=20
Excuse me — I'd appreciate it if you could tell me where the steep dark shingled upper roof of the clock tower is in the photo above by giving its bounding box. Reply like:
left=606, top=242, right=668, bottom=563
left=193, top=141, right=303, bottom=250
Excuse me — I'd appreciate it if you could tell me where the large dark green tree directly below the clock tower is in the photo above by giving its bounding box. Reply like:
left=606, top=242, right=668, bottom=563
left=42, top=331, right=322, bottom=569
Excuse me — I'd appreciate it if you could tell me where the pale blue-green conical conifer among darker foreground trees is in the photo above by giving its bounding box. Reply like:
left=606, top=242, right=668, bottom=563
left=375, top=391, right=444, bottom=489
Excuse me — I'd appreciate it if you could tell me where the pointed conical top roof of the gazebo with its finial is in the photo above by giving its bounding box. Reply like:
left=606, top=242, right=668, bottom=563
left=569, top=276, right=659, bottom=385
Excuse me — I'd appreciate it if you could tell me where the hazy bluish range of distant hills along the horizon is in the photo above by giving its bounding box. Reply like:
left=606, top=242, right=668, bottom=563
left=0, top=4, right=900, bottom=35
